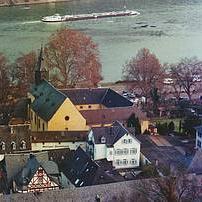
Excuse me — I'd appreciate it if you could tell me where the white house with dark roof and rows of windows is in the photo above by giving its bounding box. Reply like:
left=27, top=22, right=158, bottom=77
left=87, top=121, right=140, bottom=169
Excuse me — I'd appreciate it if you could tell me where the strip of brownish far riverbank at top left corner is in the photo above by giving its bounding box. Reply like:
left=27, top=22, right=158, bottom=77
left=0, top=0, right=72, bottom=7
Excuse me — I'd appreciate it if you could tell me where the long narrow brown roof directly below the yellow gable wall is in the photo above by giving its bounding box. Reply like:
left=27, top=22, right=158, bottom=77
left=31, top=131, right=87, bottom=143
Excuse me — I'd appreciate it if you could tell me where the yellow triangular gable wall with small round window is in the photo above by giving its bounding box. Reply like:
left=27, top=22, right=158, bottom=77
left=48, top=98, right=89, bottom=131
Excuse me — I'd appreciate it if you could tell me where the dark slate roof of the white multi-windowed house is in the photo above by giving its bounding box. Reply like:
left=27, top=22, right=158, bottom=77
left=92, top=121, right=136, bottom=146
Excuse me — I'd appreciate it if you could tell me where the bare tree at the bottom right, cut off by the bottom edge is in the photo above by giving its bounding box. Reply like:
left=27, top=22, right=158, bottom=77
left=139, top=174, right=197, bottom=202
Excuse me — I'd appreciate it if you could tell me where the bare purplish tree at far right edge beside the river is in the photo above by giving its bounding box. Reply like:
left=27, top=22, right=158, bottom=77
left=170, top=58, right=202, bottom=100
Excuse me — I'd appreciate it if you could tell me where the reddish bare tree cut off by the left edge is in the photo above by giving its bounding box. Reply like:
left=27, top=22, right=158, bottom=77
left=0, top=53, right=10, bottom=104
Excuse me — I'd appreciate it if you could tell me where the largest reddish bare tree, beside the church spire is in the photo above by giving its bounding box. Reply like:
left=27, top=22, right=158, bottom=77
left=44, top=29, right=102, bottom=88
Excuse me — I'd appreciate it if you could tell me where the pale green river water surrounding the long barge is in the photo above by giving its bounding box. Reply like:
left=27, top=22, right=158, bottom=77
left=0, top=0, right=202, bottom=82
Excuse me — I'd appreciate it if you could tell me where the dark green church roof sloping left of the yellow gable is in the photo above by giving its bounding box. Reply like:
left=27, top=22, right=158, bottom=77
left=31, top=80, right=66, bottom=121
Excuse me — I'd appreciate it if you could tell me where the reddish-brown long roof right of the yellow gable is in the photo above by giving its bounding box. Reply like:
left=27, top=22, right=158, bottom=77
left=80, top=106, right=147, bottom=125
